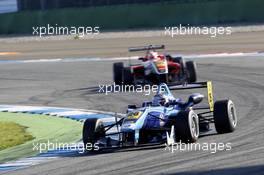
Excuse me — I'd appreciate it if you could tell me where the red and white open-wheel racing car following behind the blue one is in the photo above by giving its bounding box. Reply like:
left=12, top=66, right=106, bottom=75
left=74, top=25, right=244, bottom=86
left=113, top=45, right=197, bottom=84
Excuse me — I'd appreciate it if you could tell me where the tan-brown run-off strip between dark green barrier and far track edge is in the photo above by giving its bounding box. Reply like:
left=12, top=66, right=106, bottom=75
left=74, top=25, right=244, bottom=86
left=0, top=27, right=264, bottom=60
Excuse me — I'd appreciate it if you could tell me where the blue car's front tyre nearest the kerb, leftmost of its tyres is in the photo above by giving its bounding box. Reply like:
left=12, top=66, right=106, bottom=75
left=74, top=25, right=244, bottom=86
left=83, top=118, right=105, bottom=151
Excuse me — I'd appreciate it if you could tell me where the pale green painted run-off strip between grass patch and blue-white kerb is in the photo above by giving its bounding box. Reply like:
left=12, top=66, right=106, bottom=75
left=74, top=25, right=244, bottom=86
left=0, top=112, right=82, bottom=163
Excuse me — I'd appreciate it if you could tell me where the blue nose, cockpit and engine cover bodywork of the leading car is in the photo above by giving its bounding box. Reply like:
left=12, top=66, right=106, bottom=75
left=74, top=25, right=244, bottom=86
left=121, top=84, right=188, bottom=144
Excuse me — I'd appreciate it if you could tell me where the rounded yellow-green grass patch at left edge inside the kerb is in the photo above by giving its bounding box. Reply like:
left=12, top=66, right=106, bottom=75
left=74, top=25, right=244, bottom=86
left=0, top=121, right=34, bottom=151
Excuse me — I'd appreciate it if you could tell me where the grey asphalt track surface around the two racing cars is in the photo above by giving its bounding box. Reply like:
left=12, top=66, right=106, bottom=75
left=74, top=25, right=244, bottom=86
left=0, top=54, right=264, bottom=175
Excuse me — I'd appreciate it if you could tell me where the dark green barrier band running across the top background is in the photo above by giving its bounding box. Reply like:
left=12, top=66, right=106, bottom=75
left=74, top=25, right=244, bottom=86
left=0, top=0, right=264, bottom=34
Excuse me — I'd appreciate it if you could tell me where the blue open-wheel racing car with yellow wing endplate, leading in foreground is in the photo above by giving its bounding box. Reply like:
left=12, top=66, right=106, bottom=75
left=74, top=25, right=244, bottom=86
left=83, top=81, right=237, bottom=150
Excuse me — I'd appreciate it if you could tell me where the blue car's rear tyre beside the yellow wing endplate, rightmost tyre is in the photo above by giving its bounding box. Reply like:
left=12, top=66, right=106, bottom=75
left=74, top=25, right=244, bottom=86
left=214, top=100, right=237, bottom=134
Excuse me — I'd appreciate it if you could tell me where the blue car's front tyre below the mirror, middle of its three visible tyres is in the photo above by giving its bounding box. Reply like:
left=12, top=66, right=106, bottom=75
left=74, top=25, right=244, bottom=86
left=173, top=110, right=199, bottom=143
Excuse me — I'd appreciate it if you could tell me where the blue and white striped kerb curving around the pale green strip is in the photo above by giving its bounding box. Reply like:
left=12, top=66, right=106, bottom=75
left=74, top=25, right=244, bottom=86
left=0, top=105, right=119, bottom=173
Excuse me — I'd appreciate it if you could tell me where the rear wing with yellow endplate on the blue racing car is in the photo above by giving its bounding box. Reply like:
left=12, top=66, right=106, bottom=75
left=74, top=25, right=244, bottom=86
left=168, top=81, right=214, bottom=111
